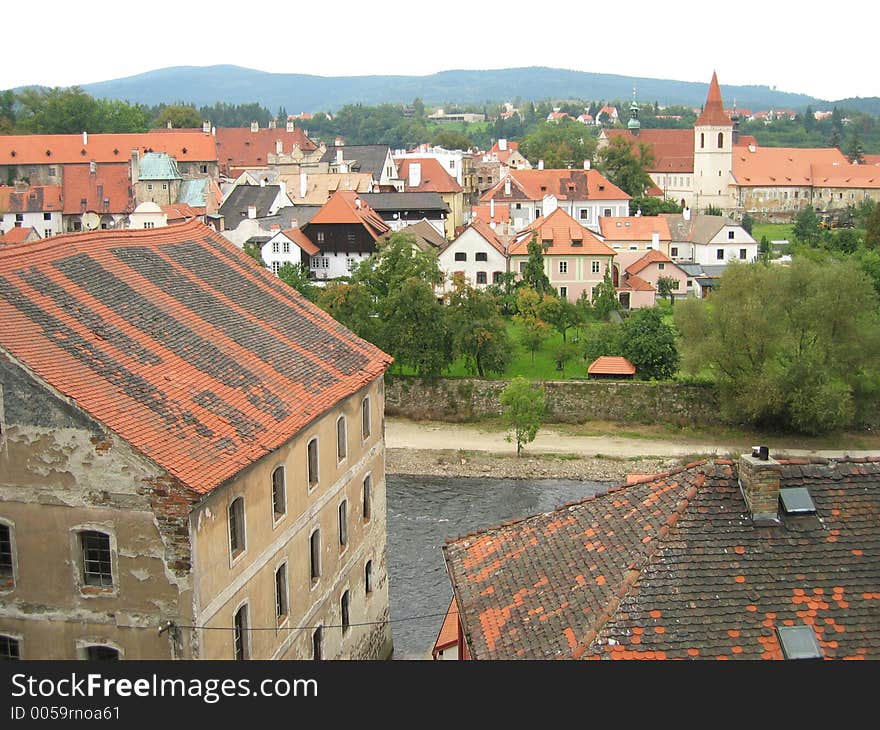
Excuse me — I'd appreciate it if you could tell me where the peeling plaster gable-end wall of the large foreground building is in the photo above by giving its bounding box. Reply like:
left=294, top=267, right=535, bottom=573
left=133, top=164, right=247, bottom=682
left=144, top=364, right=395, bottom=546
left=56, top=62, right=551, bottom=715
left=0, top=350, right=192, bottom=659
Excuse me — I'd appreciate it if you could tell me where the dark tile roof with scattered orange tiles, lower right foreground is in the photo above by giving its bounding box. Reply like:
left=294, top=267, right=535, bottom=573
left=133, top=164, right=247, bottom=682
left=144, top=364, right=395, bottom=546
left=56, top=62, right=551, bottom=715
left=443, top=457, right=880, bottom=659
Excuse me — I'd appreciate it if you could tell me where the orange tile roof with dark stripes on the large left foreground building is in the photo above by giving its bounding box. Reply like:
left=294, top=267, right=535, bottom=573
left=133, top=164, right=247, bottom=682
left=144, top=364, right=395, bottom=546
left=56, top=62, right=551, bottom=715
left=0, top=220, right=391, bottom=493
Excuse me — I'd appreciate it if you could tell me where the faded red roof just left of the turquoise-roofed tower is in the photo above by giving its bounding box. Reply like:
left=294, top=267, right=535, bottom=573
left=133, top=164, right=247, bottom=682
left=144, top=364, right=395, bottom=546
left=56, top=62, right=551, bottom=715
left=61, top=164, right=133, bottom=214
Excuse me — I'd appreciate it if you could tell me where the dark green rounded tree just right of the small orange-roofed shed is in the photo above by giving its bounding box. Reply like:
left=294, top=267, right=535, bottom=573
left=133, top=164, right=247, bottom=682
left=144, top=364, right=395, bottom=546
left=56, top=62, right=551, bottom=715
left=620, top=307, right=679, bottom=380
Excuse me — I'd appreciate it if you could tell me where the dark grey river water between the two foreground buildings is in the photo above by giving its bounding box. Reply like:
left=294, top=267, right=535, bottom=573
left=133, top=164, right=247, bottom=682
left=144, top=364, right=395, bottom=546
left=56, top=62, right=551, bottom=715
left=386, top=474, right=612, bottom=659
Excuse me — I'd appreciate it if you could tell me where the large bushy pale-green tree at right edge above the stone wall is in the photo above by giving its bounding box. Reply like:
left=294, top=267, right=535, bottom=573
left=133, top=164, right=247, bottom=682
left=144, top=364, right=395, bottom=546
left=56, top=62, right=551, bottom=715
left=675, top=257, right=880, bottom=434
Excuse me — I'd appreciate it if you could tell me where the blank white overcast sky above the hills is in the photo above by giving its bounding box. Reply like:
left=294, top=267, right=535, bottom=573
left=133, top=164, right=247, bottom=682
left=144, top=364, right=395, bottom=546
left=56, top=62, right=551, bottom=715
left=0, top=0, right=880, bottom=100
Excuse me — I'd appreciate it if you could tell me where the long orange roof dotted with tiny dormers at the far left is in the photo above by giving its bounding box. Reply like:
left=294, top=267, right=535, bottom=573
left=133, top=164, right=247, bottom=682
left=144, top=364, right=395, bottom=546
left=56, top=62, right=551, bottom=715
left=0, top=130, right=217, bottom=165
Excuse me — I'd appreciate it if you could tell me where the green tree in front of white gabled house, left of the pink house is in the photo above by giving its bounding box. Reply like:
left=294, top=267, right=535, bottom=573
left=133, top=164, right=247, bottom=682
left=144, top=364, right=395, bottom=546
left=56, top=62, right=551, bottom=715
left=449, top=282, right=513, bottom=378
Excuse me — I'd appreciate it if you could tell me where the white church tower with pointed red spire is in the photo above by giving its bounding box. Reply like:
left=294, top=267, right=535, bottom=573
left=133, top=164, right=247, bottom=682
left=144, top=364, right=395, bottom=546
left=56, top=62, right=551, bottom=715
left=694, top=73, right=736, bottom=213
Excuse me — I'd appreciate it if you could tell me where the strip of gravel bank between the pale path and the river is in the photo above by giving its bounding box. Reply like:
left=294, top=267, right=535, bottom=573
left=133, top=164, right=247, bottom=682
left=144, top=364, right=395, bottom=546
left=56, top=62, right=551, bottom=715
left=385, top=448, right=682, bottom=482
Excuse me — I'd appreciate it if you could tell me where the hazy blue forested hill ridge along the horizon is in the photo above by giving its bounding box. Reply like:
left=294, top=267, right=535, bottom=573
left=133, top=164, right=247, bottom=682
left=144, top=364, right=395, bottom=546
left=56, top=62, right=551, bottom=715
left=60, top=65, right=868, bottom=113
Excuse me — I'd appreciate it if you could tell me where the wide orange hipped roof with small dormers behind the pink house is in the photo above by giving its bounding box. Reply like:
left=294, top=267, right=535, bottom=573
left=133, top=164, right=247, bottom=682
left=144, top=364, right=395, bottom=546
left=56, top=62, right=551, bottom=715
left=480, top=169, right=631, bottom=203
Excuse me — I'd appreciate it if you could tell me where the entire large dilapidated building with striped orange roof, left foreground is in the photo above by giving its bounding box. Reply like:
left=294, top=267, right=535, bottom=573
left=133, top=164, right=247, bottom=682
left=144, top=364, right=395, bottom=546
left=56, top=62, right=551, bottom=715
left=0, top=221, right=392, bottom=659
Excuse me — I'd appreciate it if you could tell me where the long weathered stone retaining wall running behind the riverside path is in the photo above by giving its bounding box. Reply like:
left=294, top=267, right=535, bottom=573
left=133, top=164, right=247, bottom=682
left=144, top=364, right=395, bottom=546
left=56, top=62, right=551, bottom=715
left=385, top=377, right=720, bottom=425
